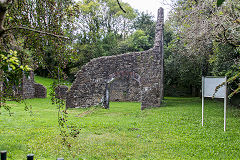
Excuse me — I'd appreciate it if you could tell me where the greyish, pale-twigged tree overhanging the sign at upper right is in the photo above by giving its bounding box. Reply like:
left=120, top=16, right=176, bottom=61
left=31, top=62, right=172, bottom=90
left=170, top=0, right=240, bottom=96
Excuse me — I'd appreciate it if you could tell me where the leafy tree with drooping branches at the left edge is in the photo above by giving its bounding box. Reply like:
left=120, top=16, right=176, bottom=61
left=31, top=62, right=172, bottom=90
left=0, top=0, right=72, bottom=109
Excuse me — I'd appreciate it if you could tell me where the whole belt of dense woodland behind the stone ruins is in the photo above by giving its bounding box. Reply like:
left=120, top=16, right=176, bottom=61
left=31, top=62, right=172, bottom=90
left=0, top=0, right=240, bottom=104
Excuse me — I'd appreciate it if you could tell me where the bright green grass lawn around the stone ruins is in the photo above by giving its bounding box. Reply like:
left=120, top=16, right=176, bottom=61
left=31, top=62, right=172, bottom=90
left=0, top=77, right=240, bottom=160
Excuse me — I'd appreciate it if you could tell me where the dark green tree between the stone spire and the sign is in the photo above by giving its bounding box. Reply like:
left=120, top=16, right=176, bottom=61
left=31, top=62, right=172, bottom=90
left=164, top=21, right=202, bottom=96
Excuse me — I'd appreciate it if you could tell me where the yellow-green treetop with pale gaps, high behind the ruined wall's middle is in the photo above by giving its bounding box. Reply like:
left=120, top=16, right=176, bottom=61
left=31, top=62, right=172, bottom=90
left=73, top=0, right=136, bottom=38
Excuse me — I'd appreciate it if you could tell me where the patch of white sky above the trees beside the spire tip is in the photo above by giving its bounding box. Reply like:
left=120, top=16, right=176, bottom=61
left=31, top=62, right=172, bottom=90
left=120, top=0, right=171, bottom=20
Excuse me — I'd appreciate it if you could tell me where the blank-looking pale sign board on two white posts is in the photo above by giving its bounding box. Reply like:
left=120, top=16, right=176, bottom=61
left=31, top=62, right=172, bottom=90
left=202, top=77, right=227, bottom=131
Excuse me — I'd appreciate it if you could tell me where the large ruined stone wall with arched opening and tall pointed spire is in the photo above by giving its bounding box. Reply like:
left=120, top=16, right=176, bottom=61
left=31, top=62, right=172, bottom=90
left=66, top=8, right=164, bottom=109
